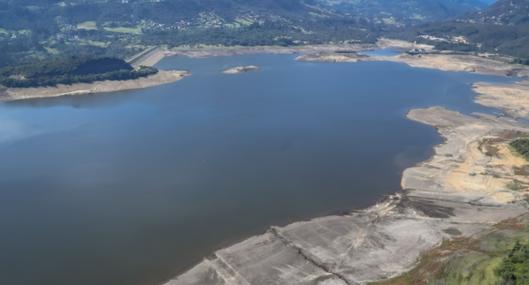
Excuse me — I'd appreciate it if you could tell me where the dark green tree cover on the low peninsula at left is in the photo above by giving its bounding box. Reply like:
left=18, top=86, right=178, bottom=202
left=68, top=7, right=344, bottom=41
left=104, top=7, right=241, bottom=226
left=0, top=57, right=158, bottom=87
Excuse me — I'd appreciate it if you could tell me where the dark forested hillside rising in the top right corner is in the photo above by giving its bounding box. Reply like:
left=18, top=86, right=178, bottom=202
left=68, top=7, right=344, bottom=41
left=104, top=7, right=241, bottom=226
left=398, top=0, right=529, bottom=59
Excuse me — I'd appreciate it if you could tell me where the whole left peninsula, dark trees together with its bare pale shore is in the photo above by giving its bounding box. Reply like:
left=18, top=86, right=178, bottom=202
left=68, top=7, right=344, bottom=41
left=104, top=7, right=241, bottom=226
left=0, top=53, right=189, bottom=101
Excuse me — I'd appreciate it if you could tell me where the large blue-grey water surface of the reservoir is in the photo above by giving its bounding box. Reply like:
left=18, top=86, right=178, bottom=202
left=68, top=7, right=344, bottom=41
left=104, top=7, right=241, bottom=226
left=0, top=54, right=506, bottom=285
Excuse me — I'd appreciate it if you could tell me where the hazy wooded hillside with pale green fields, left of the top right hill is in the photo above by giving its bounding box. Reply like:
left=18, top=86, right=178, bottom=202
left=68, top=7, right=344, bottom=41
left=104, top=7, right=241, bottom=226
left=0, top=0, right=485, bottom=66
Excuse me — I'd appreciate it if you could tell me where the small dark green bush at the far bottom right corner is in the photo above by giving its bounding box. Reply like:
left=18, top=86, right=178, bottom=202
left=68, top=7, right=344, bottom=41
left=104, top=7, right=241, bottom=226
left=498, top=241, right=529, bottom=285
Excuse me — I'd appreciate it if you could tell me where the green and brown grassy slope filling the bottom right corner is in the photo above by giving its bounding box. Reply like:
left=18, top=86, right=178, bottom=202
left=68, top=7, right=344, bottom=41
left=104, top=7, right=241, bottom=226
left=377, top=215, right=529, bottom=285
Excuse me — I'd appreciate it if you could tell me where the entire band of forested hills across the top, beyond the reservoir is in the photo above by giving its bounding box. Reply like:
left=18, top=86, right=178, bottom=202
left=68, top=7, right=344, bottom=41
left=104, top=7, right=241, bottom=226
left=4, top=0, right=529, bottom=84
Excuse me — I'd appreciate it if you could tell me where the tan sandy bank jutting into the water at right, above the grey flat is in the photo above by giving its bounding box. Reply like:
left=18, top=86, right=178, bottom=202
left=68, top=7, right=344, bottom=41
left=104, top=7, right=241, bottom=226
left=402, top=108, right=529, bottom=205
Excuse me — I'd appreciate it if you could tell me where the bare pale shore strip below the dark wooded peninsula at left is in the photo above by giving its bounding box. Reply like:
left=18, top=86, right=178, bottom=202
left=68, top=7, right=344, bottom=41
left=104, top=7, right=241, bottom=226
left=0, top=70, right=189, bottom=101
